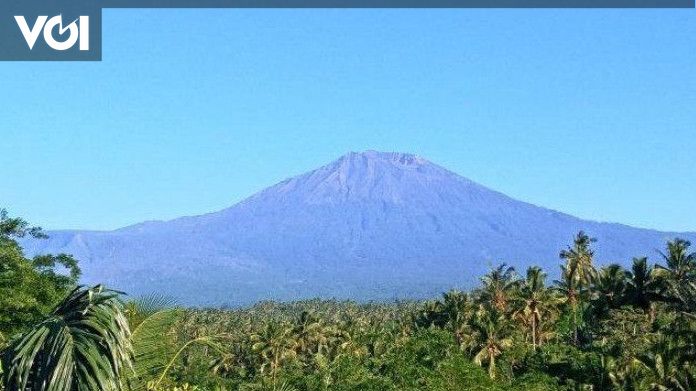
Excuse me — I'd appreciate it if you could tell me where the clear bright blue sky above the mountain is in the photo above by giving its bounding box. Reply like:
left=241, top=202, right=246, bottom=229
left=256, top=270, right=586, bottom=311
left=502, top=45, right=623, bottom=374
left=0, top=10, right=696, bottom=231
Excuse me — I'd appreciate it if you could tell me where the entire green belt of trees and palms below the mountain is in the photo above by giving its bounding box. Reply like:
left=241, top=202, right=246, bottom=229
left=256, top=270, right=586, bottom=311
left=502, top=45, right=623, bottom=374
left=0, top=211, right=696, bottom=391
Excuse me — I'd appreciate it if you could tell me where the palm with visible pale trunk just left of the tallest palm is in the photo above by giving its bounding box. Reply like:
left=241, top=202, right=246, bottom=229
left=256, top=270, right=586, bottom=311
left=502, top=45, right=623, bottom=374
left=517, top=266, right=558, bottom=350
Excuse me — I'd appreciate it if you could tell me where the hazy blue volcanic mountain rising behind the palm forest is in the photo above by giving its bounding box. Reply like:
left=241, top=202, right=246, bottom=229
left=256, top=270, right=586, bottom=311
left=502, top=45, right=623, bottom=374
left=23, top=151, right=696, bottom=305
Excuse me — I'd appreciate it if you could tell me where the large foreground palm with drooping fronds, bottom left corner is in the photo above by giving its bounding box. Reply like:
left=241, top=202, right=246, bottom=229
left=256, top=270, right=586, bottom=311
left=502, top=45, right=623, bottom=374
left=3, top=285, right=133, bottom=391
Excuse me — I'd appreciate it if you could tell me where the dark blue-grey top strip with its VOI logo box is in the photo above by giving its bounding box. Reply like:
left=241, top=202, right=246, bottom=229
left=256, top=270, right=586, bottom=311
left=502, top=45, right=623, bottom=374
left=0, top=0, right=695, bottom=61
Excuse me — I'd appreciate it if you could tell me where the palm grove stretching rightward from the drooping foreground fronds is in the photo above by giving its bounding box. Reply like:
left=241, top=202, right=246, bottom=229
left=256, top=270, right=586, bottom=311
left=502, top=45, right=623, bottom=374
left=132, top=233, right=696, bottom=391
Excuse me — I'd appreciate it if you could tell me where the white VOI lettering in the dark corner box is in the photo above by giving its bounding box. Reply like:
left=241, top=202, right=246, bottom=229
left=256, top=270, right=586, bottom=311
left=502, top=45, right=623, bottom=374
left=15, top=15, right=89, bottom=51
